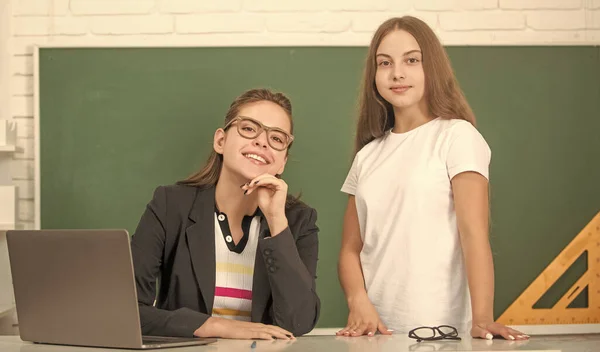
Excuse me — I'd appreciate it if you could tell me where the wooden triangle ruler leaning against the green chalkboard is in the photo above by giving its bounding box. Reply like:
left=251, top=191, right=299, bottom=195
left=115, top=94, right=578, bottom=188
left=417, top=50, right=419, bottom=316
left=497, top=213, right=600, bottom=325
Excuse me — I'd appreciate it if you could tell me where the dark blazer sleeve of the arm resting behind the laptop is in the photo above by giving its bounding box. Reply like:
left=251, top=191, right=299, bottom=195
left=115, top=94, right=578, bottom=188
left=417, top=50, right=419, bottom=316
left=131, top=187, right=209, bottom=337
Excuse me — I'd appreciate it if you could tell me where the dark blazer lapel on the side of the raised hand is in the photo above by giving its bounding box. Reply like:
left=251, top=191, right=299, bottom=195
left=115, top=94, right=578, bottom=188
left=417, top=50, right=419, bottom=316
left=250, top=217, right=271, bottom=322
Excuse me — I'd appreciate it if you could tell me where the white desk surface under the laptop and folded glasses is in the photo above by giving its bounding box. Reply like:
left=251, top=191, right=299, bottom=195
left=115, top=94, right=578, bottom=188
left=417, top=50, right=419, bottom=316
left=0, top=334, right=600, bottom=352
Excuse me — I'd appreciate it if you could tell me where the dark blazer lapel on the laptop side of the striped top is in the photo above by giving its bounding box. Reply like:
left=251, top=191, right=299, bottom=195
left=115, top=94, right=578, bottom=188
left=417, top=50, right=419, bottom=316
left=185, top=187, right=216, bottom=315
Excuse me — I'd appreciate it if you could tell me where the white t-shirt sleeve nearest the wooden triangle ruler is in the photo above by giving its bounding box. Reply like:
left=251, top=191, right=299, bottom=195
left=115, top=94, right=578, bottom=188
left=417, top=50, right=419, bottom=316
left=446, top=121, right=492, bottom=180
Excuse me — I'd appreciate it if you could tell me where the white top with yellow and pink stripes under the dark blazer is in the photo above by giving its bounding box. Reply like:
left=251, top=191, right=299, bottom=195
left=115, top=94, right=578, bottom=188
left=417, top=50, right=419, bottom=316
left=212, top=213, right=260, bottom=321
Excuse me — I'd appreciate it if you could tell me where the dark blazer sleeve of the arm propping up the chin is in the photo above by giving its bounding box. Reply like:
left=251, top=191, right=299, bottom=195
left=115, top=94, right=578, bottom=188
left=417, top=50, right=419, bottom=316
left=258, top=208, right=321, bottom=336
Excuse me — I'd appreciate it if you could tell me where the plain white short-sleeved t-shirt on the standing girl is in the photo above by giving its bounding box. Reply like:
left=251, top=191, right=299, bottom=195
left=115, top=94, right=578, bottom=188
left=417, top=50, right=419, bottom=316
left=342, top=118, right=491, bottom=332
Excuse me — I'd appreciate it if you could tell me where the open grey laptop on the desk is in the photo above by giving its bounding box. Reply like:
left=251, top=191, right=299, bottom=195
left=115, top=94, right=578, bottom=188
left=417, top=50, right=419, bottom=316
left=6, top=230, right=216, bottom=349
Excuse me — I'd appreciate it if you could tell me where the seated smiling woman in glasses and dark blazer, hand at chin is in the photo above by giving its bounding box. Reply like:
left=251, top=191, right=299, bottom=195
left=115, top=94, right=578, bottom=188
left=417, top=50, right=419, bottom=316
left=131, top=89, right=320, bottom=339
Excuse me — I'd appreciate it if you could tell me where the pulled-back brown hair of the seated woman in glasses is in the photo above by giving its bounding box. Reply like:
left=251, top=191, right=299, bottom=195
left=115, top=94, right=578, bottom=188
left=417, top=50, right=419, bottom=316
left=177, top=88, right=294, bottom=188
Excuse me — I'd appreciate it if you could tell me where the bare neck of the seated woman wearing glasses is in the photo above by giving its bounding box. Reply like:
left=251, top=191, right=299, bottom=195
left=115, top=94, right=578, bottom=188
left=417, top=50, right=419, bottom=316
left=215, top=169, right=258, bottom=218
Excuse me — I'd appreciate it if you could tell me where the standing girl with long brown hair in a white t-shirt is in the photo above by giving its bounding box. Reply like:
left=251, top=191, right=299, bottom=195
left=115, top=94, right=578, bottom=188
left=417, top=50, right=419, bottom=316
left=338, top=16, right=527, bottom=339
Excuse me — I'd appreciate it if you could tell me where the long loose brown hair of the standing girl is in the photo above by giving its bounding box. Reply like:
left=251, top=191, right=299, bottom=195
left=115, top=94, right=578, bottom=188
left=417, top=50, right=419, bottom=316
left=355, top=16, right=475, bottom=153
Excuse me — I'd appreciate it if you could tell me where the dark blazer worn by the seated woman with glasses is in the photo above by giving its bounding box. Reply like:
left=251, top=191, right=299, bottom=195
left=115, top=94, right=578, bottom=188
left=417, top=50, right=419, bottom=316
left=131, top=185, right=320, bottom=337
